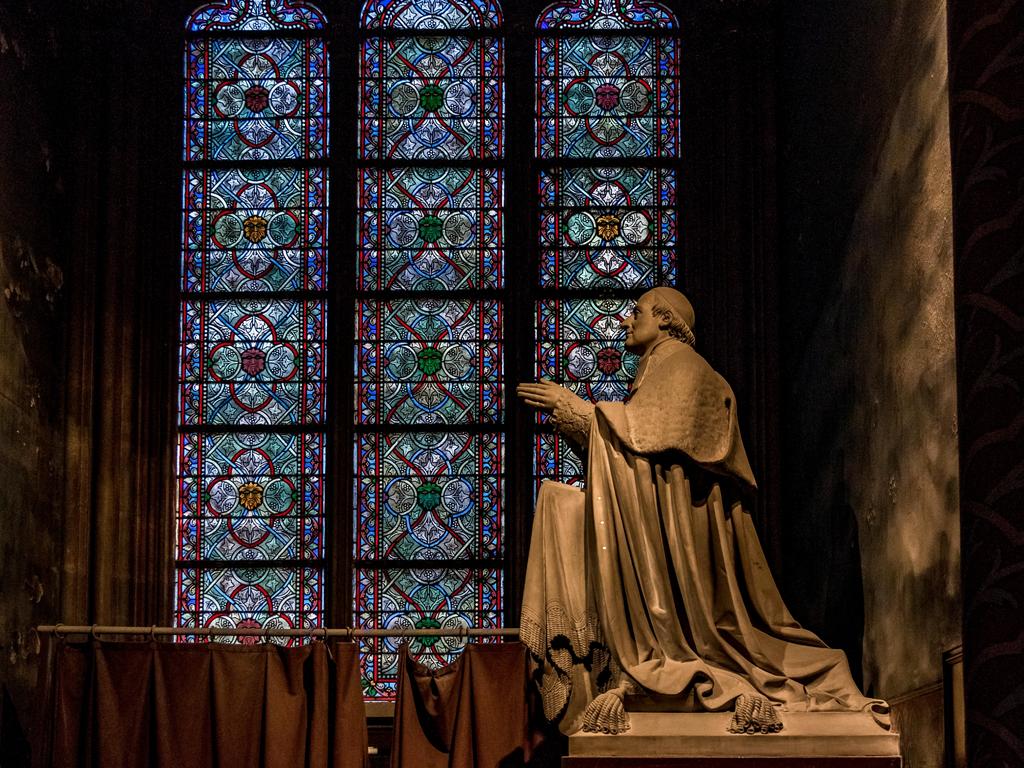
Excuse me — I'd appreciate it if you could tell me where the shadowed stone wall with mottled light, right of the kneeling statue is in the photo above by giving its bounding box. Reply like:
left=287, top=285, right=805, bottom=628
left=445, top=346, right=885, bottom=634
left=779, top=0, right=961, bottom=768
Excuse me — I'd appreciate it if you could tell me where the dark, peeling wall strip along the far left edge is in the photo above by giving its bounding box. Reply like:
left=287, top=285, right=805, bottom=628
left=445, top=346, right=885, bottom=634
left=0, top=0, right=68, bottom=749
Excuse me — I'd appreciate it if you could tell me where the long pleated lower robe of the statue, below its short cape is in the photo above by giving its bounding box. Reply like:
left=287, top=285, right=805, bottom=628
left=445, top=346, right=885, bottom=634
left=586, top=402, right=885, bottom=711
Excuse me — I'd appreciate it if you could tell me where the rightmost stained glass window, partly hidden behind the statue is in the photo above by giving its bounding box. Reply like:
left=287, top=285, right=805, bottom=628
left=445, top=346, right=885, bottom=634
left=534, top=0, right=679, bottom=484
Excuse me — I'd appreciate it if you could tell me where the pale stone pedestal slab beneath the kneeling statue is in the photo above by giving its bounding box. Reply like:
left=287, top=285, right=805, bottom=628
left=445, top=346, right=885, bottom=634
left=562, top=712, right=900, bottom=768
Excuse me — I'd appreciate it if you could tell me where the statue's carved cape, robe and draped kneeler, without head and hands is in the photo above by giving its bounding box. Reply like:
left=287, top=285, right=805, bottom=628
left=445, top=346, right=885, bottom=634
left=522, top=339, right=877, bottom=731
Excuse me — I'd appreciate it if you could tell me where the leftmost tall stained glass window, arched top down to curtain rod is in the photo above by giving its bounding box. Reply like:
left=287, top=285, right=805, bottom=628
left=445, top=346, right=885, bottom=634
left=175, top=0, right=328, bottom=642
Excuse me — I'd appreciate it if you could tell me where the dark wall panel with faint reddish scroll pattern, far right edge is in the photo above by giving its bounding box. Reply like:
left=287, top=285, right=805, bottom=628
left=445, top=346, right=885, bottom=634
left=949, top=0, right=1024, bottom=768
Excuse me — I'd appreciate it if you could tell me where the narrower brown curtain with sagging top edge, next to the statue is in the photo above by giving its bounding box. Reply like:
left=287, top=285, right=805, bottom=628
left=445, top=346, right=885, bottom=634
left=391, top=643, right=528, bottom=768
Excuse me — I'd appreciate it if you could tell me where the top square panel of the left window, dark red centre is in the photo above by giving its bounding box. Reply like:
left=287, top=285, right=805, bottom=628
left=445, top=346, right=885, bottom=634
left=185, top=37, right=328, bottom=161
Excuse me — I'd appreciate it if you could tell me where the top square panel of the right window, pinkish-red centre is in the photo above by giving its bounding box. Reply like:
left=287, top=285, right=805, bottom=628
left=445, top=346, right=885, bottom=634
left=537, top=36, right=679, bottom=162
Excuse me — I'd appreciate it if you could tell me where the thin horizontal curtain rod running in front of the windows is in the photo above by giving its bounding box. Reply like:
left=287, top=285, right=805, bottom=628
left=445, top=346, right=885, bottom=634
left=36, top=624, right=519, bottom=640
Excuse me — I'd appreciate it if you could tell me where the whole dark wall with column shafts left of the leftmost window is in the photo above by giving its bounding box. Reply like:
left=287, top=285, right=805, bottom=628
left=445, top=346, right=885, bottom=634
left=0, top=0, right=183, bottom=753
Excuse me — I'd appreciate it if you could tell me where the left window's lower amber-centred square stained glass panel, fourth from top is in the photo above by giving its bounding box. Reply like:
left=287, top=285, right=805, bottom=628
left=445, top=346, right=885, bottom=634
left=177, top=432, right=324, bottom=561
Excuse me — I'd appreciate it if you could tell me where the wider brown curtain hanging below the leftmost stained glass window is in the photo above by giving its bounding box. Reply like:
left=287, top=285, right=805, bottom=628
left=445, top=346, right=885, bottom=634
left=37, top=642, right=367, bottom=768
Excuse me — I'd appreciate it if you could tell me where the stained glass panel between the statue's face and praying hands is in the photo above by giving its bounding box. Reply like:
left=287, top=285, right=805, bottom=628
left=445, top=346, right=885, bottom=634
left=537, top=298, right=637, bottom=409
